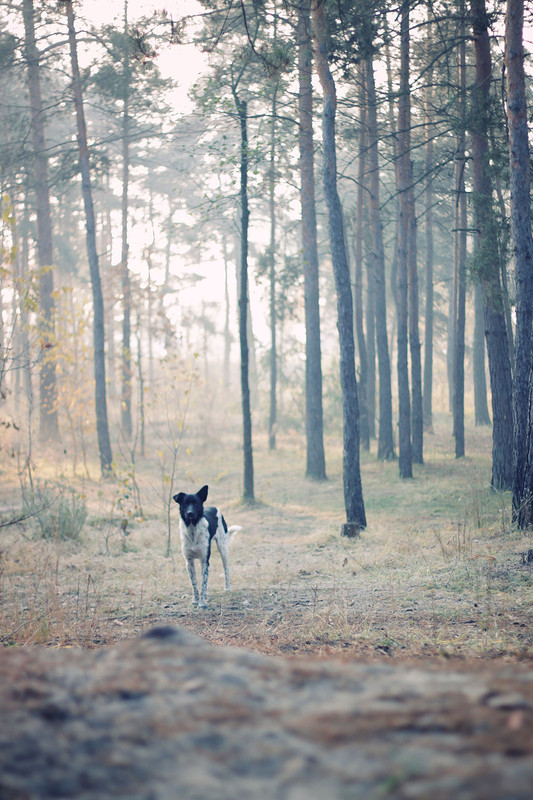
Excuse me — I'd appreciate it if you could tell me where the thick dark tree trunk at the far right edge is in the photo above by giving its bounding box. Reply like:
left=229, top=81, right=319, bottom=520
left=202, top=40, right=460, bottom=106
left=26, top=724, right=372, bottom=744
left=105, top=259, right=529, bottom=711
left=505, top=0, right=533, bottom=528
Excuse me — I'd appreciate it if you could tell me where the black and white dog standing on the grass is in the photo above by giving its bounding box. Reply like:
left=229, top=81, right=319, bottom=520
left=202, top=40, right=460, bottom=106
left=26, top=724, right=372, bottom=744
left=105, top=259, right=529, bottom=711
left=174, top=486, right=241, bottom=608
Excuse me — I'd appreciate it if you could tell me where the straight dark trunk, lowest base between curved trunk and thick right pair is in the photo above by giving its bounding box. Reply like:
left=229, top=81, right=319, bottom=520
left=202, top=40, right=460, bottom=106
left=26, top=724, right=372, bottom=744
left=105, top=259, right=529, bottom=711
left=396, top=2, right=413, bottom=478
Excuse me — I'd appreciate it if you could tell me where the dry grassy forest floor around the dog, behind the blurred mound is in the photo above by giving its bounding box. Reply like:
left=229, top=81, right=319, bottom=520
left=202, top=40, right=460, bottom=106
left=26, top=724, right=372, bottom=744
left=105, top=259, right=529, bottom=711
left=0, top=416, right=533, bottom=661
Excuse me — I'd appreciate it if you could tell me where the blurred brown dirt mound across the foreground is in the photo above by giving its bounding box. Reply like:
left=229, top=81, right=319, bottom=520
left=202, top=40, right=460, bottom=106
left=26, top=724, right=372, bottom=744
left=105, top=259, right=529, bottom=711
left=0, top=628, right=533, bottom=800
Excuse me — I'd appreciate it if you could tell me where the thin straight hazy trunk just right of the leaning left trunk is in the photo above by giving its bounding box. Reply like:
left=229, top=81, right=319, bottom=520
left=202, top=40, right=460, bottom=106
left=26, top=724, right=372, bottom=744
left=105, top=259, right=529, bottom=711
left=120, top=0, right=133, bottom=439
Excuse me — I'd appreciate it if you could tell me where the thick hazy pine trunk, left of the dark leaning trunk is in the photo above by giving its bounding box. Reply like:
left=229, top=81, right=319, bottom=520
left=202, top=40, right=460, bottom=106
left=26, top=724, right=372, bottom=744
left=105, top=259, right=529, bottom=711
left=22, top=0, right=59, bottom=441
